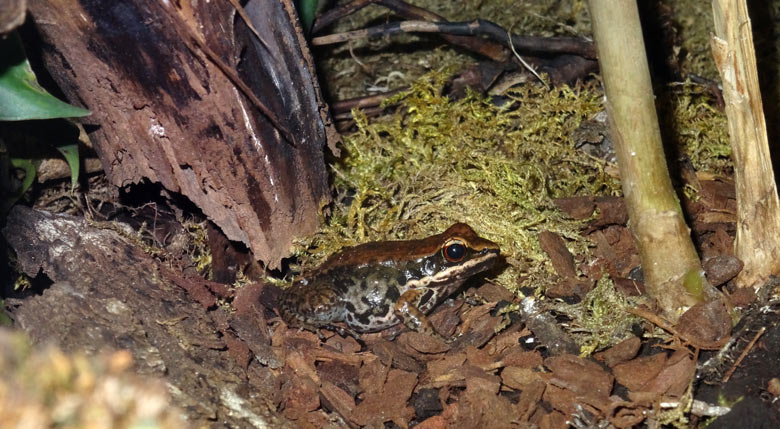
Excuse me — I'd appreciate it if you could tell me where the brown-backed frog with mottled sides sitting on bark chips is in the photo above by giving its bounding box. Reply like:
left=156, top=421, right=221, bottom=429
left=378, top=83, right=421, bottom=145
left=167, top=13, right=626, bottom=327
left=279, top=223, right=500, bottom=342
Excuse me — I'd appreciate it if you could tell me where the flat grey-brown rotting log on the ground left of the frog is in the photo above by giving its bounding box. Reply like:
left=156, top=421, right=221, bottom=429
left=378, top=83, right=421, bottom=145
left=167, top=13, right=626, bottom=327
left=3, top=206, right=289, bottom=427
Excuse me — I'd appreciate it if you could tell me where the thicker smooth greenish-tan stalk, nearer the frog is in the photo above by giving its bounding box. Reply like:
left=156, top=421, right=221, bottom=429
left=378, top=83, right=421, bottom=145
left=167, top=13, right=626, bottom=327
left=590, top=0, right=719, bottom=323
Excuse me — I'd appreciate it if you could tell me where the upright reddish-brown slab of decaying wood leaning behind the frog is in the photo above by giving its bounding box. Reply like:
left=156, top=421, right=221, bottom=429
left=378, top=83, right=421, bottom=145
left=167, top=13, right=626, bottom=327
left=29, top=0, right=336, bottom=267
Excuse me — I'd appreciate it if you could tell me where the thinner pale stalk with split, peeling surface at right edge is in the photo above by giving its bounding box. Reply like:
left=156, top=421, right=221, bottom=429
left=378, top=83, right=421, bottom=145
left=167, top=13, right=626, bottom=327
left=710, top=0, right=780, bottom=288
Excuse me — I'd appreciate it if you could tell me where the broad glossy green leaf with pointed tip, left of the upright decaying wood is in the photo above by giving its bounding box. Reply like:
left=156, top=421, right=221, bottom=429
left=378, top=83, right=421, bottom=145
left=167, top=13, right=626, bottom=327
left=0, top=32, right=91, bottom=121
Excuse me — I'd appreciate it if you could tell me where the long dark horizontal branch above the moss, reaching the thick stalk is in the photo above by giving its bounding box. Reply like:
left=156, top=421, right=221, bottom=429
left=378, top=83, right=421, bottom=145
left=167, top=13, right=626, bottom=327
left=312, top=19, right=596, bottom=58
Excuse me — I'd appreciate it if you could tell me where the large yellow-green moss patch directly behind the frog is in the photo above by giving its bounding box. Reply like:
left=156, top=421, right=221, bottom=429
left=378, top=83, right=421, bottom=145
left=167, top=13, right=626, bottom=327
left=296, top=72, right=618, bottom=290
